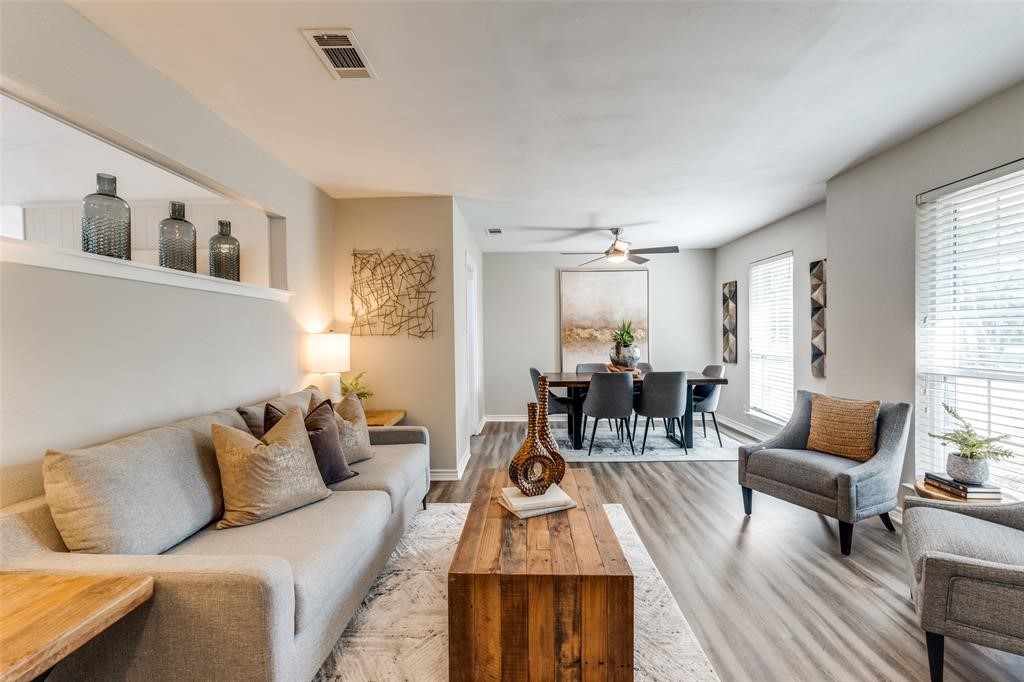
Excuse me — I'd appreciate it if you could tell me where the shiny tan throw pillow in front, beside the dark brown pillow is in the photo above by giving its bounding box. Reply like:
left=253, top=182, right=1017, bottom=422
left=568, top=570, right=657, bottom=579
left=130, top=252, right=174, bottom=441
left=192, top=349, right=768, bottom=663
left=211, top=408, right=331, bottom=528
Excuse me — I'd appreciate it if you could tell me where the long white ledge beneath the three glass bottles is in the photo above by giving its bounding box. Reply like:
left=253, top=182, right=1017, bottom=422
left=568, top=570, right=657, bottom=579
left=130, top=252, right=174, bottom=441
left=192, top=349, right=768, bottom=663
left=0, top=237, right=294, bottom=303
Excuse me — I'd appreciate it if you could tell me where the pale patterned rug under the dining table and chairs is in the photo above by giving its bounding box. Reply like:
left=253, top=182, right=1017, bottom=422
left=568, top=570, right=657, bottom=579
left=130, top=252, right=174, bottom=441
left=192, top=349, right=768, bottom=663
left=552, top=420, right=739, bottom=462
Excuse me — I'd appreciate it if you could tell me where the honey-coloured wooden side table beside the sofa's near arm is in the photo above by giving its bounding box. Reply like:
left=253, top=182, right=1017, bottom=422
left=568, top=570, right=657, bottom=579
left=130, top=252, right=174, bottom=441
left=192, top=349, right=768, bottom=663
left=0, top=573, right=153, bottom=682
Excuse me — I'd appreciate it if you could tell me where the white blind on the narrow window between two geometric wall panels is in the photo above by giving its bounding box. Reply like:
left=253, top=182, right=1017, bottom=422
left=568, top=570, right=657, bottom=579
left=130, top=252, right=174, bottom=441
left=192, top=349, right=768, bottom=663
left=748, top=253, right=793, bottom=421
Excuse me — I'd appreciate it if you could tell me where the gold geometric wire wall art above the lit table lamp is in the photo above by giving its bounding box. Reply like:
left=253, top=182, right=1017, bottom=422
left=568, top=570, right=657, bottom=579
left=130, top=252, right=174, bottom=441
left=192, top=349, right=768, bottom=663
left=351, top=249, right=437, bottom=339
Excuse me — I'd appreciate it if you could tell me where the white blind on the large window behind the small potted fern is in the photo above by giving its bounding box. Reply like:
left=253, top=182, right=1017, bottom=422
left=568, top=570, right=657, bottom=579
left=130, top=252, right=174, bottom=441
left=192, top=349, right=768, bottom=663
left=914, top=163, right=1024, bottom=491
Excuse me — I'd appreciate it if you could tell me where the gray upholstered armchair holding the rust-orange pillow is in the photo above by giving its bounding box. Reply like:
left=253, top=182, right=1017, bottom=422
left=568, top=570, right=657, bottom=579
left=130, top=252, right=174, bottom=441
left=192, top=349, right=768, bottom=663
left=739, top=391, right=913, bottom=555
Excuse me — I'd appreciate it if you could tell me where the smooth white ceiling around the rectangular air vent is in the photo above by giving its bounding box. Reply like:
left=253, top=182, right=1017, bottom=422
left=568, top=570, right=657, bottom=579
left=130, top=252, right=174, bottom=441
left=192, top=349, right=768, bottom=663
left=71, top=0, right=1024, bottom=251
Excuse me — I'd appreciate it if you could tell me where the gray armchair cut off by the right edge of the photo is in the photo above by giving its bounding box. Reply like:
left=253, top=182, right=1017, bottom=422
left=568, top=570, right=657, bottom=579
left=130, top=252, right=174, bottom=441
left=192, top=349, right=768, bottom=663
left=903, top=497, right=1024, bottom=682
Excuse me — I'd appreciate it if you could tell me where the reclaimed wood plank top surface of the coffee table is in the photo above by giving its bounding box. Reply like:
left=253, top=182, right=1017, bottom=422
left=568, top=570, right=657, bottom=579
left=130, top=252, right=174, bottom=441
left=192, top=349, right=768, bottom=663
left=449, top=469, right=632, bottom=576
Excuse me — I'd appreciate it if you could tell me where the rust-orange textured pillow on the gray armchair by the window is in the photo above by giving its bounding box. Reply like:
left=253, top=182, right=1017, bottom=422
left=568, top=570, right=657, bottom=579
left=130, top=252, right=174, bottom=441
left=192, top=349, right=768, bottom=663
left=807, top=393, right=882, bottom=462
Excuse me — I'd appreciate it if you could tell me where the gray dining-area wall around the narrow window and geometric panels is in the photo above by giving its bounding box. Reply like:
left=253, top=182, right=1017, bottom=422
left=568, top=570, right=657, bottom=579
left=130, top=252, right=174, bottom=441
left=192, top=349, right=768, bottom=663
left=711, top=203, right=833, bottom=433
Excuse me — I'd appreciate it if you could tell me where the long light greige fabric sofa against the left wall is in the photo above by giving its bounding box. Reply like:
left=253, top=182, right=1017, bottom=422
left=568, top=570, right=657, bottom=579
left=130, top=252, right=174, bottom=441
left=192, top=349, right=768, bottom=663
left=0, top=387, right=429, bottom=682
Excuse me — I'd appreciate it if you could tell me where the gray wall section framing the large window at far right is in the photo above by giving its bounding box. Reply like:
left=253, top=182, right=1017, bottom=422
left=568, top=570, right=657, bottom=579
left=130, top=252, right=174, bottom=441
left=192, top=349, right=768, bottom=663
left=826, top=84, right=1024, bottom=479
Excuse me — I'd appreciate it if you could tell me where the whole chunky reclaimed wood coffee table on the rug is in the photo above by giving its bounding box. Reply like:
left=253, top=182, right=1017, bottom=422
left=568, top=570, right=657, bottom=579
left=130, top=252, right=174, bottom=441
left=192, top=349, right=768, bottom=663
left=449, top=469, right=633, bottom=680
